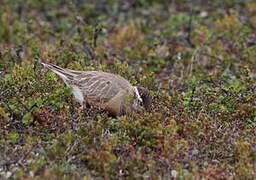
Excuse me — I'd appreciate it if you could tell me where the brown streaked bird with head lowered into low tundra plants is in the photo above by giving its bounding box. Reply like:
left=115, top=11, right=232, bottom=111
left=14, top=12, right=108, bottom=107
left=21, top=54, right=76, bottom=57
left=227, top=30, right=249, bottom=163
left=40, top=62, right=152, bottom=116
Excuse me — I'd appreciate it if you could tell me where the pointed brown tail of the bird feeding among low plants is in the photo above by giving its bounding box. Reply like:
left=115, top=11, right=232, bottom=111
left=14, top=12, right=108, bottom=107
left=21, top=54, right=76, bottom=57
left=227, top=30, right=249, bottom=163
left=40, top=62, right=76, bottom=82
